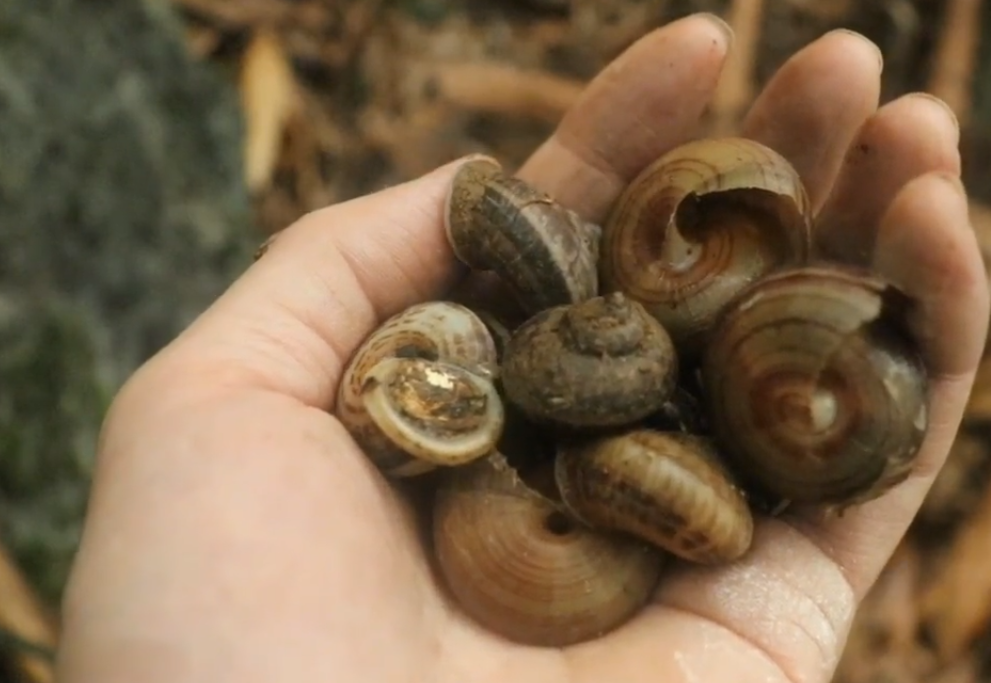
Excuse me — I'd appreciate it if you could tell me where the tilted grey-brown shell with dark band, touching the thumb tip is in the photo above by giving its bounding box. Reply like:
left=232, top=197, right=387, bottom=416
left=444, top=159, right=602, bottom=314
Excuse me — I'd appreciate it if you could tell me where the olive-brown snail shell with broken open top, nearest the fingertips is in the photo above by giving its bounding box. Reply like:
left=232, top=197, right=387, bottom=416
left=602, top=138, right=811, bottom=353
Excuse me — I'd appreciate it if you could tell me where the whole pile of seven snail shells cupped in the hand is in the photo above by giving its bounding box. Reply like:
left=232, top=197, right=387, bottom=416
left=336, top=138, right=927, bottom=646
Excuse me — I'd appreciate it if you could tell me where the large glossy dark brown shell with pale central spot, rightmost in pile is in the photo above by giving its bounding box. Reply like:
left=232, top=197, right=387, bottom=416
left=702, top=265, right=928, bottom=507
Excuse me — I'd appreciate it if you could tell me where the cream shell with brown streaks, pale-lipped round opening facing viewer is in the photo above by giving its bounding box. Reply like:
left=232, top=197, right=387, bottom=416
left=336, top=302, right=505, bottom=477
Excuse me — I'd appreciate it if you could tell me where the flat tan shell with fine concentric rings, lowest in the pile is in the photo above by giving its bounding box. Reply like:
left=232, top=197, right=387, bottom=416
left=434, top=452, right=665, bottom=647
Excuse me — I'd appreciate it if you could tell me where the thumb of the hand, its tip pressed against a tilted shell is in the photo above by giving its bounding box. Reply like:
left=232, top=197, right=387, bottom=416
left=160, top=157, right=488, bottom=407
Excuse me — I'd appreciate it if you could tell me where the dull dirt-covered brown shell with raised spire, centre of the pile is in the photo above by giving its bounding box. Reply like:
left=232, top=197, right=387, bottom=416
left=500, top=292, right=678, bottom=428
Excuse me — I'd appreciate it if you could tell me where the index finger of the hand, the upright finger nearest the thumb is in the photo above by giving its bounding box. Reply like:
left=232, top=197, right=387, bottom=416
left=517, top=14, right=730, bottom=221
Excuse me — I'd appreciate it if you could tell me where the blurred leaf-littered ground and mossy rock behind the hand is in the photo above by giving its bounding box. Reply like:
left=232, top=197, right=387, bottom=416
left=0, top=0, right=991, bottom=683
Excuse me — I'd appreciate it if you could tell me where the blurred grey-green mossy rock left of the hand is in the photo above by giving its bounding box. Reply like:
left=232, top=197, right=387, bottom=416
left=0, top=0, right=257, bottom=603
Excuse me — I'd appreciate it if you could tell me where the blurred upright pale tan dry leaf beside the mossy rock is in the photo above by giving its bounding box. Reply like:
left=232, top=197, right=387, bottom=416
left=241, top=31, right=299, bottom=192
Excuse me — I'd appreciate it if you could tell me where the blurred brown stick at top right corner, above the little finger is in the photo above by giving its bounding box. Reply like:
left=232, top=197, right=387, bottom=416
left=928, top=0, right=981, bottom=125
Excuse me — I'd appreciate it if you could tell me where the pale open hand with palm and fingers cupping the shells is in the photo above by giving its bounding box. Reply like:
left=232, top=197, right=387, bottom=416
left=58, top=16, right=988, bottom=683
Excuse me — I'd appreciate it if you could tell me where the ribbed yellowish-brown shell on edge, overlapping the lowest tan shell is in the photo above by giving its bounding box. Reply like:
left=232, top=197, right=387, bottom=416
left=555, top=429, right=754, bottom=564
